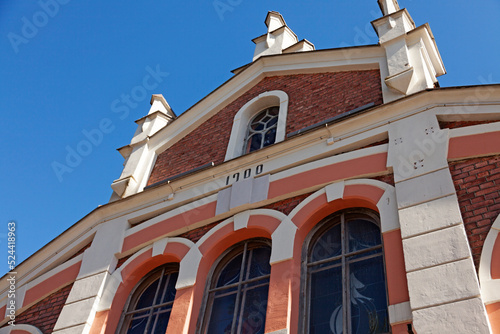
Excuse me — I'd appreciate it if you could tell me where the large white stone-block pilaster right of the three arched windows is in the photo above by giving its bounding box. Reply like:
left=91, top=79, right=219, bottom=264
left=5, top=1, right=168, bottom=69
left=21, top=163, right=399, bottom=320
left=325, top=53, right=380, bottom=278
left=388, top=115, right=490, bottom=333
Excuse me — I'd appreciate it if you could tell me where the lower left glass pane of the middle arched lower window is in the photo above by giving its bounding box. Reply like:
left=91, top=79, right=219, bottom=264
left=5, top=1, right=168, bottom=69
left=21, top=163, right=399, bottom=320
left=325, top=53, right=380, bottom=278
left=207, top=293, right=236, bottom=334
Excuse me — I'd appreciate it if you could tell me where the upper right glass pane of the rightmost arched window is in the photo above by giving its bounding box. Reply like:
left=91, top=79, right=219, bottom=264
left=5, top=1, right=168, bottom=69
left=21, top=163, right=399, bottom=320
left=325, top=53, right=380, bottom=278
left=347, top=219, right=381, bottom=252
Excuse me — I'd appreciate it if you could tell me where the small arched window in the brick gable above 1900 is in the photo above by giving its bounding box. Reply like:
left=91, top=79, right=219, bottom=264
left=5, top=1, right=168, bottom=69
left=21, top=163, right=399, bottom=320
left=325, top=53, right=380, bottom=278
left=244, top=107, right=280, bottom=153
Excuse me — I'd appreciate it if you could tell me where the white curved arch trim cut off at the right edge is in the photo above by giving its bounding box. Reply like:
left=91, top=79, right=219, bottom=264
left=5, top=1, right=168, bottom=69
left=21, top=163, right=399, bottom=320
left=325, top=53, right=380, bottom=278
left=479, top=215, right=500, bottom=304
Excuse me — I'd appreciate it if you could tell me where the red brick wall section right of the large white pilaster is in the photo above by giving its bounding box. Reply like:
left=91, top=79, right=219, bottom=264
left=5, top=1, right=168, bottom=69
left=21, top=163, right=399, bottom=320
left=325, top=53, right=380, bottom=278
left=450, top=156, right=500, bottom=269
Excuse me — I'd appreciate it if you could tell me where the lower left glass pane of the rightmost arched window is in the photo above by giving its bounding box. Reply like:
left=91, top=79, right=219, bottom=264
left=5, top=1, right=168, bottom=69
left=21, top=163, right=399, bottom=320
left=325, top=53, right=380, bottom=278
left=309, top=267, right=343, bottom=334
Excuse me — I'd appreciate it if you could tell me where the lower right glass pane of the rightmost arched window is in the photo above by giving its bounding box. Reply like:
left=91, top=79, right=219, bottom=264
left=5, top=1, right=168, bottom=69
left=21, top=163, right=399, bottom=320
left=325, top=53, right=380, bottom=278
left=349, top=256, right=389, bottom=334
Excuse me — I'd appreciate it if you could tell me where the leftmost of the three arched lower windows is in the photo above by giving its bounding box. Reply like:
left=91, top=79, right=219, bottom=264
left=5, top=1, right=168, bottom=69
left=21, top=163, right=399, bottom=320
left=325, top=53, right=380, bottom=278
left=120, top=264, right=179, bottom=334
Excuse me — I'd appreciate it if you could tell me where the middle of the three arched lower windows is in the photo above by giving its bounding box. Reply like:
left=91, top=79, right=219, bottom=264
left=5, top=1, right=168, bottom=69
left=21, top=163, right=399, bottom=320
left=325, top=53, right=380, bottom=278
left=202, top=240, right=271, bottom=334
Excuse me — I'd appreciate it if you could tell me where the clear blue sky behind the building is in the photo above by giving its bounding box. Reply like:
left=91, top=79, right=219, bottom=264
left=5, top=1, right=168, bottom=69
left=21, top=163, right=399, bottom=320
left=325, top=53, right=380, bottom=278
left=0, top=0, right=500, bottom=272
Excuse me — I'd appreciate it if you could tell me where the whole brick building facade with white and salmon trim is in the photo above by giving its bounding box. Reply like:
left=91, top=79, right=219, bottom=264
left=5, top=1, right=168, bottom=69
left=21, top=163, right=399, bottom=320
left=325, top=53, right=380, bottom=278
left=0, top=0, right=500, bottom=334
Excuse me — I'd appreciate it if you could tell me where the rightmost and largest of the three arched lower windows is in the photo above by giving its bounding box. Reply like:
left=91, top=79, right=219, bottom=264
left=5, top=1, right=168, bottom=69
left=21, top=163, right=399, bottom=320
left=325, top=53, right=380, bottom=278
left=303, top=210, right=390, bottom=334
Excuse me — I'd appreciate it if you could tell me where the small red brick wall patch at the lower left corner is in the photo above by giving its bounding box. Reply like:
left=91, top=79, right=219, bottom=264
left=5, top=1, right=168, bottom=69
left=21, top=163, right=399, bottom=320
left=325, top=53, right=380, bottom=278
left=16, top=284, right=73, bottom=334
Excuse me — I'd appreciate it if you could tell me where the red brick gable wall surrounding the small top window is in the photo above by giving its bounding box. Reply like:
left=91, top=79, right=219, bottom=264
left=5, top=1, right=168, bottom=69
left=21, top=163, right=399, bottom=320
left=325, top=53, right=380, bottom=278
left=148, top=70, right=383, bottom=185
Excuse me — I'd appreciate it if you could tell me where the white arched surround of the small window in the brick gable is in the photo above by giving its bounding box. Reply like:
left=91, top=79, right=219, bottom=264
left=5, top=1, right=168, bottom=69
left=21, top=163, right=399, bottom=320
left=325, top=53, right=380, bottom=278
left=224, top=90, right=288, bottom=161
